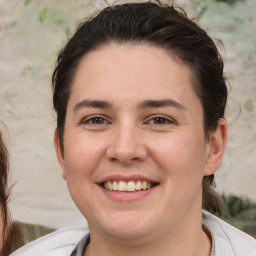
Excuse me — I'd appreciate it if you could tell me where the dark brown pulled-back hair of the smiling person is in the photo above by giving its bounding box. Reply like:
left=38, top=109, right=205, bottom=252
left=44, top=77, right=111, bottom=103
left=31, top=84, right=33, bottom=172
left=52, top=2, right=227, bottom=211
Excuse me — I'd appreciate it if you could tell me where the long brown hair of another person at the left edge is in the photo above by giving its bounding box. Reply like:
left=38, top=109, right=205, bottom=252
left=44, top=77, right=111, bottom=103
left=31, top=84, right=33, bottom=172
left=0, top=131, right=12, bottom=255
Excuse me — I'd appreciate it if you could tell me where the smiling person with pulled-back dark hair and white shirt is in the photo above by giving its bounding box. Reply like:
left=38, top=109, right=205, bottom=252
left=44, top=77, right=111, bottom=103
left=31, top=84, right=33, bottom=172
left=9, top=3, right=256, bottom=256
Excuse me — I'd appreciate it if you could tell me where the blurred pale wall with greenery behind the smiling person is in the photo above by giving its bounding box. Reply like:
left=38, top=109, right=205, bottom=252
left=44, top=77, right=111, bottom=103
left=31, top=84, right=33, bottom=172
left=0, top=0, right=256, bottom=249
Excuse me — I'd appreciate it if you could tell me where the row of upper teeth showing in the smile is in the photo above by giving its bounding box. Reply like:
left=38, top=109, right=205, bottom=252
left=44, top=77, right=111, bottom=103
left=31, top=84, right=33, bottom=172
left=103, top=180, right=153, bottom=192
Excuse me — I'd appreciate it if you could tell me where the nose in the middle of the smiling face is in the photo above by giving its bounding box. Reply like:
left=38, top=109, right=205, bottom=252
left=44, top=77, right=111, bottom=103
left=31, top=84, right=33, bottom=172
left=106, top=125, right=147, bottom=165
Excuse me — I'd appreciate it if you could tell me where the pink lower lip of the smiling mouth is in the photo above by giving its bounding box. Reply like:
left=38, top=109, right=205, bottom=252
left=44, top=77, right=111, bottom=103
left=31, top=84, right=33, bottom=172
left=99, top=186, right=158, bottom=202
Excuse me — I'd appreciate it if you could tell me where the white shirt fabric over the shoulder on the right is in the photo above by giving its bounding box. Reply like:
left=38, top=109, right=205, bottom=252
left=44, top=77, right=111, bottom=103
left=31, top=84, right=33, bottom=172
left=203, top=211, right=256, bottom=256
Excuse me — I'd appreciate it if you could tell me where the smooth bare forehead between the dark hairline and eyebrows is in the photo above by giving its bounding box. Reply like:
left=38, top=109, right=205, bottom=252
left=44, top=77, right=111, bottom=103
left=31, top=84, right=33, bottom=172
left=70, top=43, right=201, bottom=111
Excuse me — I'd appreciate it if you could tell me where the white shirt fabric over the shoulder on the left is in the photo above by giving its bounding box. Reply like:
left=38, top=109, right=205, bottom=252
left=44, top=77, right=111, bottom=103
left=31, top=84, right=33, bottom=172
left=10, top=227, right=88, bottom=256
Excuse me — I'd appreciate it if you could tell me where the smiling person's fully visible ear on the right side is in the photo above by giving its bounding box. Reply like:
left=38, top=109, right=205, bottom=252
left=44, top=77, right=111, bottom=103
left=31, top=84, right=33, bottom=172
left=204, top=118, right=227, bottom=176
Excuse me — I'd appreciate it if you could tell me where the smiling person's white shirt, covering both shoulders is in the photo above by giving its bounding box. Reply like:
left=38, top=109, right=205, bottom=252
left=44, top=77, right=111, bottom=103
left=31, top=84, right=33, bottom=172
left=10, top=211, right=256, bottom=256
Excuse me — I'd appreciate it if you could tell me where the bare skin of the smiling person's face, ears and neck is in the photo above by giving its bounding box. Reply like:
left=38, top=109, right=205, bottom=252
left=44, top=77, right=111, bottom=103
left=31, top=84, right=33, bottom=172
left=55, top=44, right=226, bottom=256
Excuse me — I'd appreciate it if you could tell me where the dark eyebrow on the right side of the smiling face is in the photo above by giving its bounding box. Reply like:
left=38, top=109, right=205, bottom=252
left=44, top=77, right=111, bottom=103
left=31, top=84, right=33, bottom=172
left=139, top=99, right=186, bottom=110
